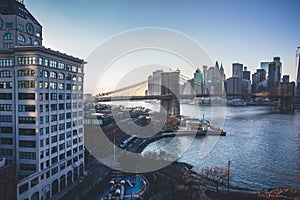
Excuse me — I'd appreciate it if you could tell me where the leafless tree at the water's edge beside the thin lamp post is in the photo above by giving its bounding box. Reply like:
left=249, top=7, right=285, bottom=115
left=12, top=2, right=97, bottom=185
left=202, top=166, right=233, bottom=191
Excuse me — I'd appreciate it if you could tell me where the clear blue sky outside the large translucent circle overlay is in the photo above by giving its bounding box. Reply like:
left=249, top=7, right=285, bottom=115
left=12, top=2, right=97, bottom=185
left=25, top=0, right=300, bottom=92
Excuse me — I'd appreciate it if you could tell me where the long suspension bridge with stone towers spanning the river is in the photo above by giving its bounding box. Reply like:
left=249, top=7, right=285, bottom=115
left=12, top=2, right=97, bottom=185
left=96, top=75, right=300, bottom=116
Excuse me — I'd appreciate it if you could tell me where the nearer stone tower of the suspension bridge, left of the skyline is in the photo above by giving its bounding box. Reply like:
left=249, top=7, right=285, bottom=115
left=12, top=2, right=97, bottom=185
left=160, top=70, right=180, bottom=117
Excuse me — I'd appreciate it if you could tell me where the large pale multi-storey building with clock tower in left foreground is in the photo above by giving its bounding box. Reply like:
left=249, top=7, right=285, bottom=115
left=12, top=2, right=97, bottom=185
left=0, top=0, right=84, bottom=199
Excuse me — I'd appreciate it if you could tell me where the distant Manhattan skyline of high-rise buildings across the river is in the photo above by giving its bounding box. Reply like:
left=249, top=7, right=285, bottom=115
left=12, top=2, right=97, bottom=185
left=147, top=47, right=300, bottom=96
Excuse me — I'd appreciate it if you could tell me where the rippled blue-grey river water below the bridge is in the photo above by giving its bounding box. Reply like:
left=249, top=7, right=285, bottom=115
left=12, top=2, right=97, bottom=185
left=139, top=104, right=300, bottom=190
